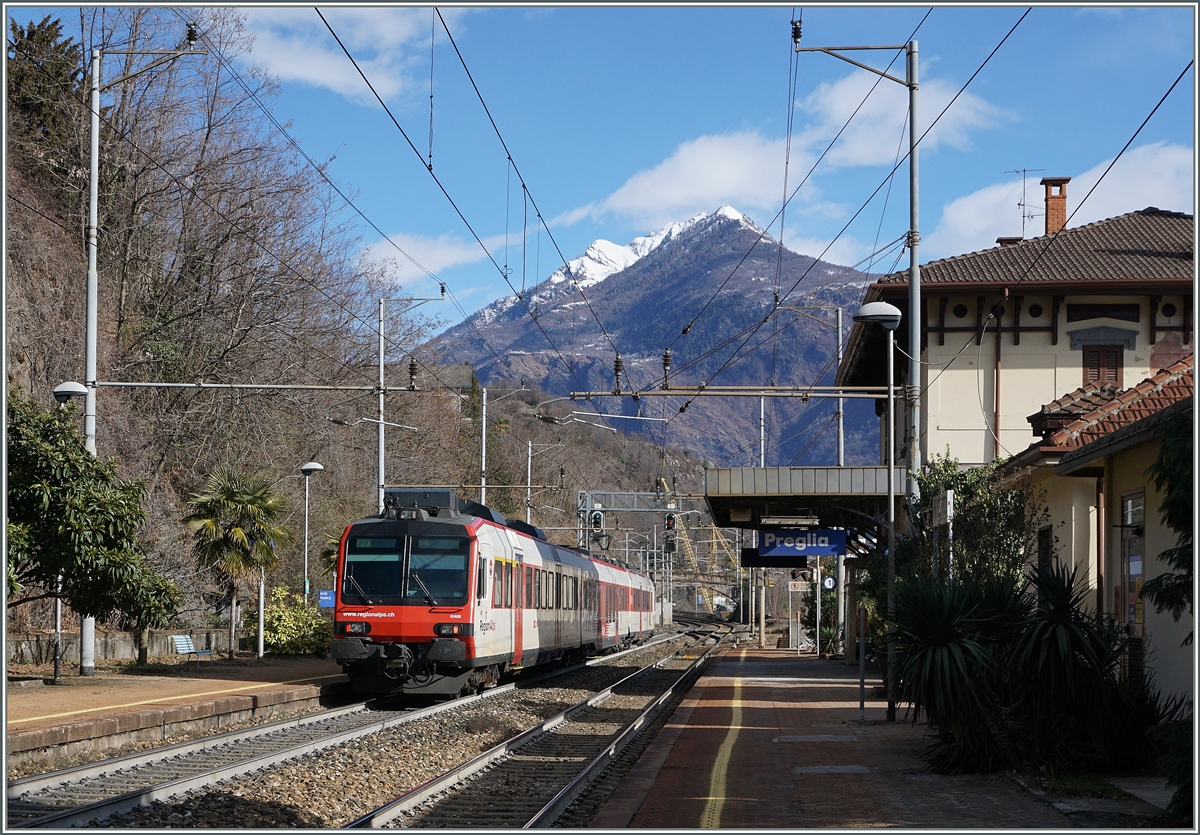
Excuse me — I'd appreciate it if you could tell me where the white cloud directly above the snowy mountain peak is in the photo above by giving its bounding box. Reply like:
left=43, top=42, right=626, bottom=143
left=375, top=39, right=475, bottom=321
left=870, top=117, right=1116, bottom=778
left=554, top=131, right=797, bottom=229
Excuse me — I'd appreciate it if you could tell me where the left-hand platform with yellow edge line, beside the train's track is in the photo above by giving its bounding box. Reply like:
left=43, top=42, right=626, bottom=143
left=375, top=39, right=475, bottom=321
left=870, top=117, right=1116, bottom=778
left=5, top=656, right=349, bottom=768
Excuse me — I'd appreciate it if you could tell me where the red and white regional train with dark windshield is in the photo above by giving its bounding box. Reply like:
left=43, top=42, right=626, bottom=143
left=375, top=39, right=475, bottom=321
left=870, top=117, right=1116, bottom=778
left=332, top=488, right=654, bottom=696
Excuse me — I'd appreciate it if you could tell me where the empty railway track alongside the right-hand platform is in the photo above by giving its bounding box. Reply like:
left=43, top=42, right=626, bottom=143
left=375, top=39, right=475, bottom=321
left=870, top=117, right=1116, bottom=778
left=347, top=630, right=728, bottom=830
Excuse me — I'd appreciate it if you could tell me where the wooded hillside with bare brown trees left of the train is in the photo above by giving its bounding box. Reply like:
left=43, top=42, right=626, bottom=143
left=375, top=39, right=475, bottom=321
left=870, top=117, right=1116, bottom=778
left=5, top=8, right=698, bottom=630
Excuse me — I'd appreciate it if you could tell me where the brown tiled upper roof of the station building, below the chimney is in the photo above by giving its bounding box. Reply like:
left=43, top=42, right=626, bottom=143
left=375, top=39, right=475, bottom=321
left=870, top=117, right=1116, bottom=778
left=877, top=208, right=1193, bottom=286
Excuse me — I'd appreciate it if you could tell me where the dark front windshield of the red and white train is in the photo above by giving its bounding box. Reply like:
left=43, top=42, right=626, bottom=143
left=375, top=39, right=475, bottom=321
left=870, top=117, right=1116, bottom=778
left=342, top=536, right=468, bottom=606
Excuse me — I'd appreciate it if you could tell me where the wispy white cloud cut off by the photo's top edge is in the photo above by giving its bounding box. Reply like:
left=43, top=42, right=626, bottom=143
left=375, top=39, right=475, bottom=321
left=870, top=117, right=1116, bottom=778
left=244, top=6, right=467, bottom=103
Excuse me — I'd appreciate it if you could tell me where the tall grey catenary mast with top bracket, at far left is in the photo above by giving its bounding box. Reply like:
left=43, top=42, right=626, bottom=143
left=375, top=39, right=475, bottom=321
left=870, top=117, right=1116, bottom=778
left=78, top=23, right=208, bottom=675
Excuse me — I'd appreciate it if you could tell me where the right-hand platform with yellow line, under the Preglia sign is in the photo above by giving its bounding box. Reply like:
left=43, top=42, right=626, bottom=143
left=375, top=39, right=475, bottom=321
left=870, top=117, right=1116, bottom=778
left=592, top=648, right=1140, bottom=829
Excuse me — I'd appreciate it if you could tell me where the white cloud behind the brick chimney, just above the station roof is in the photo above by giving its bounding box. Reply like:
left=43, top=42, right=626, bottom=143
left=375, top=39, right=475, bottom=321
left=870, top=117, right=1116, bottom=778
left=922, top=143, right=1195, bottom=260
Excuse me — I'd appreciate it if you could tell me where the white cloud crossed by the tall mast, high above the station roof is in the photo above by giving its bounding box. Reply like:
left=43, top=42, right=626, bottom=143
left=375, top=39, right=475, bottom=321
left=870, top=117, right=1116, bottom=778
left=797, top=68, right=1012, bottom=167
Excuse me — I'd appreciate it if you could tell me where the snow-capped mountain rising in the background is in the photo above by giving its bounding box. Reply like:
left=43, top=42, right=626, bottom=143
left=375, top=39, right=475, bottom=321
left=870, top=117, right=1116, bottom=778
left=430, top=206, right=870, bottom=463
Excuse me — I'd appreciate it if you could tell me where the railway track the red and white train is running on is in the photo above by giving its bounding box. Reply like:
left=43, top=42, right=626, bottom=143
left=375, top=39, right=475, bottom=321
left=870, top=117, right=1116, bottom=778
left=7, top=647, right=696, bottom=828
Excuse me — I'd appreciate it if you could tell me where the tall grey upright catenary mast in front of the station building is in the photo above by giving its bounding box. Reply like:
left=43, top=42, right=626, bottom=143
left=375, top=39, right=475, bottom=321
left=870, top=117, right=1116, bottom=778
left=902, top=41, right=925, bottom=508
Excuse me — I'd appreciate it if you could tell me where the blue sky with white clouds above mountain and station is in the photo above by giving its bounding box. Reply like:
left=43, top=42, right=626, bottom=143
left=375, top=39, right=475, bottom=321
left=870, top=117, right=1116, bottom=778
left=6, top=5, right=1196, bottom=333
